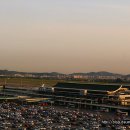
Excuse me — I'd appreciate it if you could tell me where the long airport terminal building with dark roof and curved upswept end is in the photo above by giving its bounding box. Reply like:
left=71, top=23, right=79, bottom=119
left=39, top=82, right=130, bottom=111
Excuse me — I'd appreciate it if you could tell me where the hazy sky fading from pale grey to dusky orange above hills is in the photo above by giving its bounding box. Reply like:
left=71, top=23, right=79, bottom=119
left=0, top=0, right=130, bottom=74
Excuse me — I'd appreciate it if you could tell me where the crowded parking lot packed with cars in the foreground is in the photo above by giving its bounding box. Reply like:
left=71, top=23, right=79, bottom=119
left=0, top=102, right=130, bottom=130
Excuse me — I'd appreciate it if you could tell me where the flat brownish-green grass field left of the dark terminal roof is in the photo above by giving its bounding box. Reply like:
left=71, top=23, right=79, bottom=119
left=0, top=78, right=63, bottom=87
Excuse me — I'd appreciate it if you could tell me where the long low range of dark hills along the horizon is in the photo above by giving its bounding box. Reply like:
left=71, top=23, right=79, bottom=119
left=0, top=70, right=130, bottom=77
